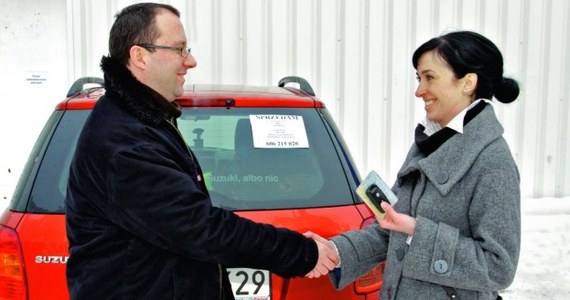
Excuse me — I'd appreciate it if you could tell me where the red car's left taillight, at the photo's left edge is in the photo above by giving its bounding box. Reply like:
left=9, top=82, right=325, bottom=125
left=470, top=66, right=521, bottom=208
left=0, top=226, right=26, bottom=299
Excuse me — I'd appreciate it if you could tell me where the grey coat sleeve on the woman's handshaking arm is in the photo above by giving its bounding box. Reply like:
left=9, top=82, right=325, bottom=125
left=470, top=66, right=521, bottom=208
left=329, top=221, right=389, bottom=290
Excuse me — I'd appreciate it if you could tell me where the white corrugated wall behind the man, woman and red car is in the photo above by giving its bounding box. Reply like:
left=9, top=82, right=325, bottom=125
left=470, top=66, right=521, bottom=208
left=0, top=0, right=570, bottom=202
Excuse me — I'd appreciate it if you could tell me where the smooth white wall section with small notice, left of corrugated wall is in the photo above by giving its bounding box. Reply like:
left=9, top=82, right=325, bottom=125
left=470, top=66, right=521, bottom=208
left=0, top=0, right=69, bottom=202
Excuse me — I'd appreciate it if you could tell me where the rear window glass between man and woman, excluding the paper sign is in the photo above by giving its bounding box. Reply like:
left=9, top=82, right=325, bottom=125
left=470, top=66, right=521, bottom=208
left=178, top=108, right=352, bottom=209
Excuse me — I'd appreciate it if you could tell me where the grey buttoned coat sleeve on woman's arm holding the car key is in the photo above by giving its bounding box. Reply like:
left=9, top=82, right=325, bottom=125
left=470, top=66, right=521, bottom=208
left=403, top=149, right=520, bottom=291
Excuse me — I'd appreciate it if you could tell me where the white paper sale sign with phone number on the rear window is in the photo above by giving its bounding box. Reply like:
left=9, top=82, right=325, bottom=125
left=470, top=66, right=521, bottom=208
left=249, top=115, right=309, bottom=148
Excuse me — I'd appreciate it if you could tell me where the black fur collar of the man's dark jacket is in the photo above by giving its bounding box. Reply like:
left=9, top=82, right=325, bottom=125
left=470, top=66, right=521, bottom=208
left=101, top=56, right=181, bottom=125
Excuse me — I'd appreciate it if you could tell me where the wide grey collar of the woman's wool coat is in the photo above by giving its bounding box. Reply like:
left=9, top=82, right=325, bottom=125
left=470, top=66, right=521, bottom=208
left=398, top=105, right=504, bottom=195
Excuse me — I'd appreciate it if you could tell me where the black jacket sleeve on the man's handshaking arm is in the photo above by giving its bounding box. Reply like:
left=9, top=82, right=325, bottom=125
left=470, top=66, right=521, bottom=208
left=108, top=144, right=318, bottom=277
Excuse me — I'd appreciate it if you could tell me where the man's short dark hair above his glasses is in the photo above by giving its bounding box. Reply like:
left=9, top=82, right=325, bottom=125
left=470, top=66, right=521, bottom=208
left=109, top=3, right=180, bottom=66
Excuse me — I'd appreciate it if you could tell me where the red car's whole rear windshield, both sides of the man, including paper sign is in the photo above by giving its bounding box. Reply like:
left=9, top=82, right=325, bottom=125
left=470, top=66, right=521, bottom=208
left=22, top=108, right=353, bottom=213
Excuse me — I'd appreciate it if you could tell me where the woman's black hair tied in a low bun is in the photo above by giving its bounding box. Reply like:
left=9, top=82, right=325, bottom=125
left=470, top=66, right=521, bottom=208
left=412, top=31, right=519, bottom=103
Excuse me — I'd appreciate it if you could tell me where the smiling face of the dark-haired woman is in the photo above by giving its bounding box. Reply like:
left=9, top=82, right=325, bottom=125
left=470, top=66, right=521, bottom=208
left=416, top=51, right=470, bottom=126
